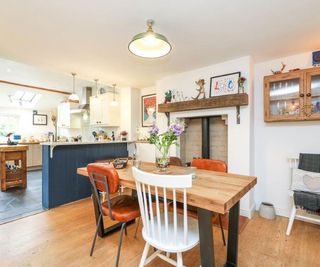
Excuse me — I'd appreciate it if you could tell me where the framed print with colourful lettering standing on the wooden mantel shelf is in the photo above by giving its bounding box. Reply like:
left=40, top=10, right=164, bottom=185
left=210, top=71, right=241, bottom=97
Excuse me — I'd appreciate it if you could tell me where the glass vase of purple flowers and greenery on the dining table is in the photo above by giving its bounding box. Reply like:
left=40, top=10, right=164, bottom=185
left=148, top=123, right=183, bottom=172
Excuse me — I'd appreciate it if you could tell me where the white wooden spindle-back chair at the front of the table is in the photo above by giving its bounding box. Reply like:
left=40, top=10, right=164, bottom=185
left=132, top=167, right=199, bottom=267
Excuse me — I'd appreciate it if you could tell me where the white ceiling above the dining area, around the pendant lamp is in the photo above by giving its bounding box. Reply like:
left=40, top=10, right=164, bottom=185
left=0, top=0, right=320, bottom=87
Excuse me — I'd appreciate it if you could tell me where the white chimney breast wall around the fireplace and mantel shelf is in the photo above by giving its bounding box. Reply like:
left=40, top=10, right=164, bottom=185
left=156, top=57, right=254, bottom=216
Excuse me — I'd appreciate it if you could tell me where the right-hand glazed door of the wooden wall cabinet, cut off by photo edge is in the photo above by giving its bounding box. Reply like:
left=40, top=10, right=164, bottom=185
left=307, top=73, right=320, bottom=117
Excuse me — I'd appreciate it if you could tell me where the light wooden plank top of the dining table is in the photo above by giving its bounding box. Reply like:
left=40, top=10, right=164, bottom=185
left=77, top=161, right=257, bottom=214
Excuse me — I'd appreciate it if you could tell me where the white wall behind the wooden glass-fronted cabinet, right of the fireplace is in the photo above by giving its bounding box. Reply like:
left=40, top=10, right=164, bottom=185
left=254, top=52, right=320, bottom=216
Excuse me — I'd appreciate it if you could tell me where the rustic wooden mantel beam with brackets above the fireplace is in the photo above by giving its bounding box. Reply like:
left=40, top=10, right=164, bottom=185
left=158, top=93, right=249, bottom=124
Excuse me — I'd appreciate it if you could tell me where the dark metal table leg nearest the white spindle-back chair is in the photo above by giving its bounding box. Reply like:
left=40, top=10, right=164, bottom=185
left=197, top=208, right=214, bottom=267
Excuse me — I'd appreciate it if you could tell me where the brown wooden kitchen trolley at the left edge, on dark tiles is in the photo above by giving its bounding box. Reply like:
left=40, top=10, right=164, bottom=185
left=0, top=145, right=28, bottom=191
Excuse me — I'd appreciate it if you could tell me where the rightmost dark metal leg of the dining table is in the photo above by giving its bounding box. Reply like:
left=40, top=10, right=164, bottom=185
left=225, top=201, right=240, bottom=267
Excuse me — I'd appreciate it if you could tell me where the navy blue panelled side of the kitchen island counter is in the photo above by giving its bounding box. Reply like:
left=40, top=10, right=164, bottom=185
left=42, top=142, right=128, bottom=209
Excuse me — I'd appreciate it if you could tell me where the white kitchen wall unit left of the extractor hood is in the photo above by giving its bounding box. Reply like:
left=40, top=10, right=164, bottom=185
left=57, top=102, right=81, bottom=129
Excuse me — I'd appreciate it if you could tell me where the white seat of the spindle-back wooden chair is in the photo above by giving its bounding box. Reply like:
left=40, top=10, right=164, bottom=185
left=142, top=212, right=199, bottom=253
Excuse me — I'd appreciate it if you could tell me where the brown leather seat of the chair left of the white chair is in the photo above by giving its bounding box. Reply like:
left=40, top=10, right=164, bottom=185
left=101, top=195, right=140, bottom=222
